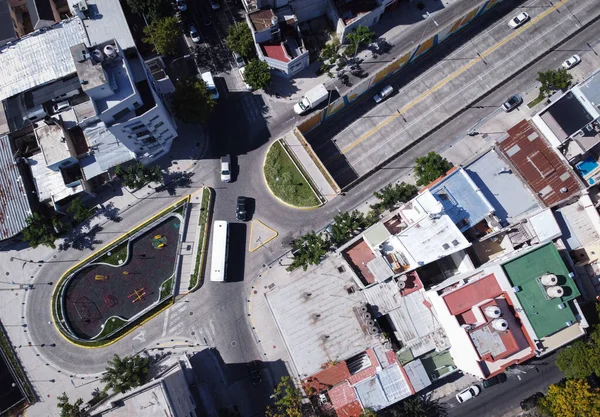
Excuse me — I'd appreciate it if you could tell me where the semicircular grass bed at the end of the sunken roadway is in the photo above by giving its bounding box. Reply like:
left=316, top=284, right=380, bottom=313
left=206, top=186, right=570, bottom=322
left=264, top=141, right=320, bottom=207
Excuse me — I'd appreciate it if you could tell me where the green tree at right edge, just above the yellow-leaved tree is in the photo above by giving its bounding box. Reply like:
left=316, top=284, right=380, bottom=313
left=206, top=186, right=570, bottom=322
left=556, top=326, right=600, bottom=379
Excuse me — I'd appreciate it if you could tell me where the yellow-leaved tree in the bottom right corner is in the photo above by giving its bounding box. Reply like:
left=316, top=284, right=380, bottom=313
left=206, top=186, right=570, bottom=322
left=538, top=379, right=600, bottom=417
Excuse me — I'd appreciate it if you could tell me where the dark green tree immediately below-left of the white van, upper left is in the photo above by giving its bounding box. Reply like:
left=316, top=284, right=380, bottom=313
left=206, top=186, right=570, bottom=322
left=171, top=78, right=216, bottom=123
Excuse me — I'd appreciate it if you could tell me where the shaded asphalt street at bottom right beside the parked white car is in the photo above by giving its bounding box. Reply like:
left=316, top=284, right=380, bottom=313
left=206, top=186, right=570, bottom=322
left=442, top=353, right=564, bottom=417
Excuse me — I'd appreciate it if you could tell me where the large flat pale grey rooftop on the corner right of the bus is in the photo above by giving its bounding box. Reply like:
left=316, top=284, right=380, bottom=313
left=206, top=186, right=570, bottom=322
left=267, top=259, right=377, bottom=376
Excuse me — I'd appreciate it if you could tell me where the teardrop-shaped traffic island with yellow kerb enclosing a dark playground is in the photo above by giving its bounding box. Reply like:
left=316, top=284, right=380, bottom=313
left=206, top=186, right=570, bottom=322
left=52, top=196, right=190, bottom=347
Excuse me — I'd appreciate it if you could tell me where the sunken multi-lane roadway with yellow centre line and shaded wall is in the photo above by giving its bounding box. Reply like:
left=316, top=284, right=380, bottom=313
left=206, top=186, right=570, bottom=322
left=306, top=2, right=575, bottom=188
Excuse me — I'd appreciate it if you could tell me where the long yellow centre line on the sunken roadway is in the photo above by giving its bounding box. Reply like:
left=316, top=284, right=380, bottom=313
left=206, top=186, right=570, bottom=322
left=338, top=0, right=569, bottom=156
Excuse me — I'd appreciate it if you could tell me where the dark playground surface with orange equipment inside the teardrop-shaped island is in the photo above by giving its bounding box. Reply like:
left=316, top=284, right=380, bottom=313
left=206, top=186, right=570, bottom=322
left=62, top=214, right=182, bottom=340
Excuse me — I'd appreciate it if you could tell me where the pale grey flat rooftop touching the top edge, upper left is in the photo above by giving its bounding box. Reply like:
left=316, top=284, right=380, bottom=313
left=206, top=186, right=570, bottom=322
left=69, top=0, right=135, bottom=49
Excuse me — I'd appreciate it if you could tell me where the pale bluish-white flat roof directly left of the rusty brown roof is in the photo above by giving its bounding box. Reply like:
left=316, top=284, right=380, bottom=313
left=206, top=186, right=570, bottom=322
left=465, top=149, right=542, bottom=225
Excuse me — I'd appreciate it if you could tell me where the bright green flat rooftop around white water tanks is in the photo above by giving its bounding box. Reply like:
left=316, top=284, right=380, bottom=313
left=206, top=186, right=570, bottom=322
left=502, top=243, right=579, bottom=338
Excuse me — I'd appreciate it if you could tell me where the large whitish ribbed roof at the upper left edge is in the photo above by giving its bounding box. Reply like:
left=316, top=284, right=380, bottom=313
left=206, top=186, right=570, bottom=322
left=0, top=18, right=87, bottom=100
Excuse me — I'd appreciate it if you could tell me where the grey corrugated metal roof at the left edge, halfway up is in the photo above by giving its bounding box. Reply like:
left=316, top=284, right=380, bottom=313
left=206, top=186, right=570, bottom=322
left=0, top=135, right=31, bottom=240
